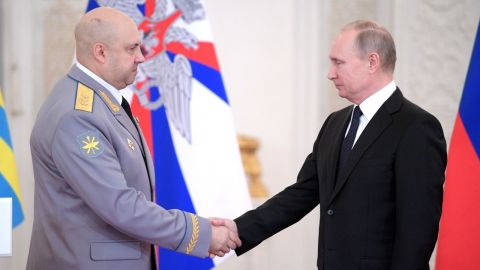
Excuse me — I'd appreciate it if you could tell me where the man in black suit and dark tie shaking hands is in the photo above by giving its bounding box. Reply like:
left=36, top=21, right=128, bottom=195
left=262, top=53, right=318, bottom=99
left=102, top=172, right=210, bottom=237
left=213, top=21, right=446, bottom=270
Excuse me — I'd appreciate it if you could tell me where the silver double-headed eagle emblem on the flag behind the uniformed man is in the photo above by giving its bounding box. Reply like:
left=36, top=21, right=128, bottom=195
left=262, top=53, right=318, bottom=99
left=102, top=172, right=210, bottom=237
left=97, top=0, right=205, bottom=143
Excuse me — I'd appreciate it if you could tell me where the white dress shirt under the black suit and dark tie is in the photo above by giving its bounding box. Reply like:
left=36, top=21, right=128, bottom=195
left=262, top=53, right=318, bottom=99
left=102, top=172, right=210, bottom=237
left=345, top=81, right=397, bottom=148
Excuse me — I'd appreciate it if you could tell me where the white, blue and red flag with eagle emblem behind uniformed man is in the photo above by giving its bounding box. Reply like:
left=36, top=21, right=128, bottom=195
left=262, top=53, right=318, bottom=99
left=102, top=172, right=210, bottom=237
left=87, top=0, right=251, bottom=269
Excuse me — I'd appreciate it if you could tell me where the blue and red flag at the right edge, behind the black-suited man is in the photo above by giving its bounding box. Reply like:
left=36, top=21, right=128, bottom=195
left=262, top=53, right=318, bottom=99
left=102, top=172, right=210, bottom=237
left=435, top=20, right=480, bottom=270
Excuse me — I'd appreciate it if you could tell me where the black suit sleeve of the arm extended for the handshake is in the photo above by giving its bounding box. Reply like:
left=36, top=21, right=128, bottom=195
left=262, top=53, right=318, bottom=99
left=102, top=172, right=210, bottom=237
left=235, top=114, right=328, bottom=255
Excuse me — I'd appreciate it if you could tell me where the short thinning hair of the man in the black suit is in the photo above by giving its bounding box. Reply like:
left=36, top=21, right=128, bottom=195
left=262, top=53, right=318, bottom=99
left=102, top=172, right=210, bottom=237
left=342, top=20, right=397, bottom=73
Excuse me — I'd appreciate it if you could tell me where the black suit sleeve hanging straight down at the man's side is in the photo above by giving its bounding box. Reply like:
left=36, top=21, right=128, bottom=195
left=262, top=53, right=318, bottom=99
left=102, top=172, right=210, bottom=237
left=391, top=115, right=446, bottom=270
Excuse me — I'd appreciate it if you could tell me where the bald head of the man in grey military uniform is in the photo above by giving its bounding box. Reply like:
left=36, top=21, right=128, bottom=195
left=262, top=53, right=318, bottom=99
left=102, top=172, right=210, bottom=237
left=75, top=7, right=145, bottom=89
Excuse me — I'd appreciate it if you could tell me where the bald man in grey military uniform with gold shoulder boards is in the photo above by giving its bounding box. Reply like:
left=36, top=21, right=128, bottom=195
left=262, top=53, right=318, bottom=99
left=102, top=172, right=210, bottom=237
left=27, top=8, right=241, bottom=270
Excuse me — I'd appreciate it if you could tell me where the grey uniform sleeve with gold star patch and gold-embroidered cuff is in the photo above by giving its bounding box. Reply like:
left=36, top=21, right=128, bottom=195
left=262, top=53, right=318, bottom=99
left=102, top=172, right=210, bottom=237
left=51, top=111, right=211, bottom=257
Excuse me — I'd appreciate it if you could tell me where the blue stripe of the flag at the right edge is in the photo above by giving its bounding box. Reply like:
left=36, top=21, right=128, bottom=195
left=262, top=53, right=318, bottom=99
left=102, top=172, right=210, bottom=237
left=459, top=21, right=480, bottom=158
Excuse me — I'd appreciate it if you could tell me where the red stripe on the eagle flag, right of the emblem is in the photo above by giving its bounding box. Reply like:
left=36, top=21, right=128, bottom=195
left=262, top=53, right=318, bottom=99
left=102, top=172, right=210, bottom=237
left=167, top=42, right=220, bottom=71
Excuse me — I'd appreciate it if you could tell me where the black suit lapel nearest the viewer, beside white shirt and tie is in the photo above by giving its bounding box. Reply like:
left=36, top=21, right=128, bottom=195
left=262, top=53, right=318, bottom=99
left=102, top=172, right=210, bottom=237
left=329, top=88, right=403, bottom=204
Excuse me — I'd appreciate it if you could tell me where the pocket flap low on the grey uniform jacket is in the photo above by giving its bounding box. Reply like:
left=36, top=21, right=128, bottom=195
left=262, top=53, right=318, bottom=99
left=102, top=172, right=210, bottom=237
left=90, top=241, right=142, bottom=261
